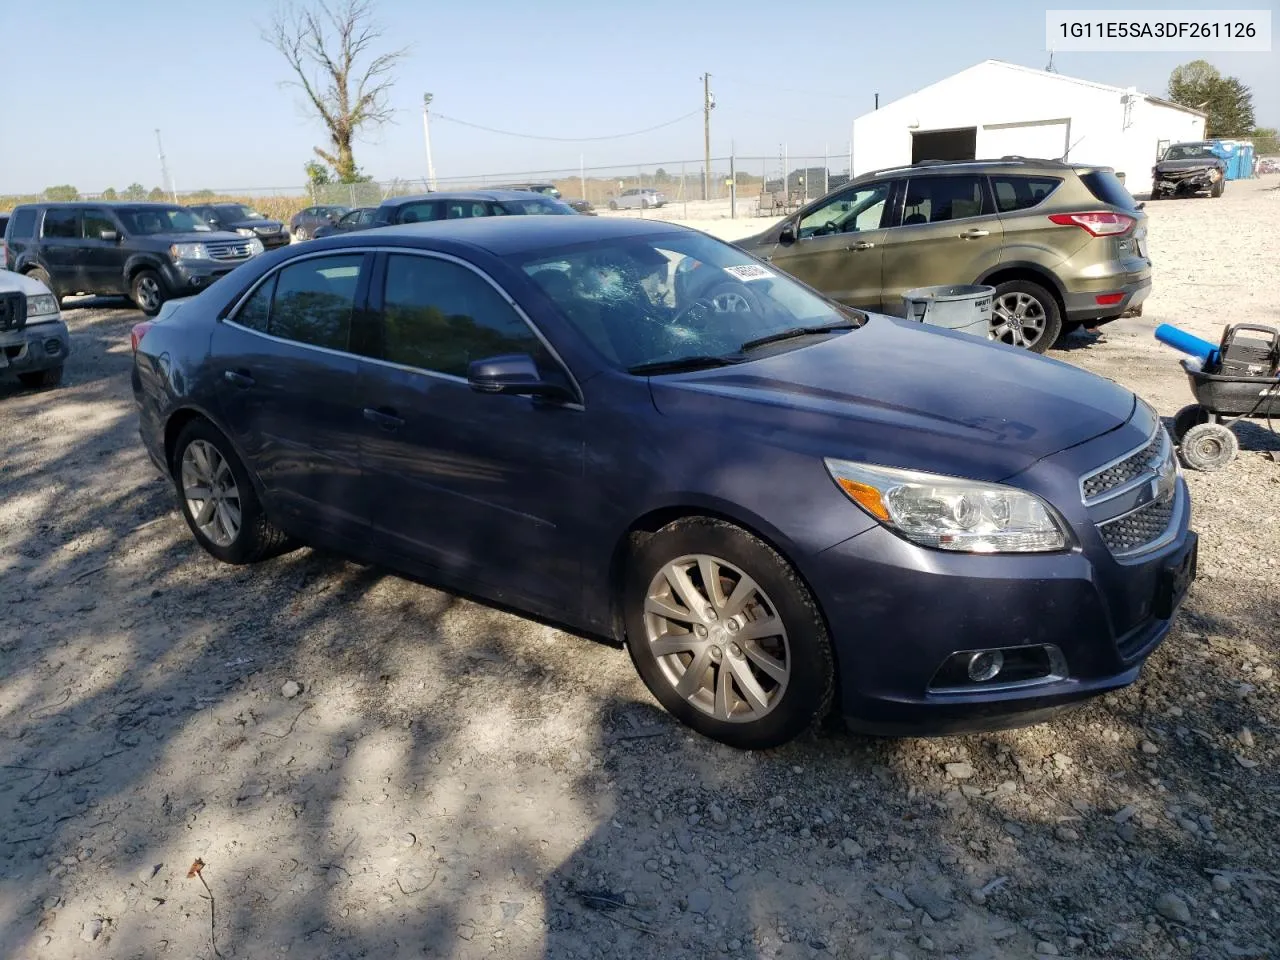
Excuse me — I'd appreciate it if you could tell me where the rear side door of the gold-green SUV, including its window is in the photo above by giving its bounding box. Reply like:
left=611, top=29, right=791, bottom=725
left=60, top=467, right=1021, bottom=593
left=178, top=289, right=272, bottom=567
left=881, top=174, right=1004, bottom=316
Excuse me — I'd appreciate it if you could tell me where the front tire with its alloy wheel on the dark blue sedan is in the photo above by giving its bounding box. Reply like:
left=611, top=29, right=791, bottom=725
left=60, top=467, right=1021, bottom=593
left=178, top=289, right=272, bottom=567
left=622, top=517, right=835, bottom=750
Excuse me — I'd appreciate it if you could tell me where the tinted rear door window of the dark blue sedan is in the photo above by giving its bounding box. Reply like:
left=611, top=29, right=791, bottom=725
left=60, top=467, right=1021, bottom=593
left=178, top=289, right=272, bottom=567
left=266, top=253, right=364, bottom=349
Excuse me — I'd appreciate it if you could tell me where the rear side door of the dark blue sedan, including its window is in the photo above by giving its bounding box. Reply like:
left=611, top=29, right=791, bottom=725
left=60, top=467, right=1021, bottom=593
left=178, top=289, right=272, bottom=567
left=211, top=251, right=372, bottom=541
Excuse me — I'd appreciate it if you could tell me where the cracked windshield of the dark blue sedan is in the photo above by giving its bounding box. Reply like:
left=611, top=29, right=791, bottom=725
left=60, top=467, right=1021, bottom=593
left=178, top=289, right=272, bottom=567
left=517, top=233, right=860, bottom=369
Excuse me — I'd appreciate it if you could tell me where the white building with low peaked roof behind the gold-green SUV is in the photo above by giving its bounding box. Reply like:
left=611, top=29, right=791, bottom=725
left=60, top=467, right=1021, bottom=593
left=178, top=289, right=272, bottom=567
left=854, top=60, right=1204, bottom=196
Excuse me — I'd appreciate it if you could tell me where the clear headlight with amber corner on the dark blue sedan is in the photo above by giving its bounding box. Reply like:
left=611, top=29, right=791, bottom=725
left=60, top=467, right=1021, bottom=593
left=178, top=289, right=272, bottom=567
left=826, top=460, right=1066, bottom=553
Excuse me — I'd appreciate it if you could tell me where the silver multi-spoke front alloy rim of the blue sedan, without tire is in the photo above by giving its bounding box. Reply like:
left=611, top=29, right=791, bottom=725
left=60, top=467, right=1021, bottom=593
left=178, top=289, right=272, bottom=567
left=644, top=554, right=791, bottom=723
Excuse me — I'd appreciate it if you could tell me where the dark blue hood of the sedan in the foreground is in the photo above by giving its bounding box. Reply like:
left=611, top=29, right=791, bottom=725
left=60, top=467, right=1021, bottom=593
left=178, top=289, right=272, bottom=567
left=650, top=315, right=1135, bottom=481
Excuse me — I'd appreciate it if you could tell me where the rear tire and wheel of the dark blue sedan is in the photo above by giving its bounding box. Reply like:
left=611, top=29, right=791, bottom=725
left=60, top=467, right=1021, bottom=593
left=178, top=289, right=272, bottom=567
left=170, top=420, right=294, bottom=563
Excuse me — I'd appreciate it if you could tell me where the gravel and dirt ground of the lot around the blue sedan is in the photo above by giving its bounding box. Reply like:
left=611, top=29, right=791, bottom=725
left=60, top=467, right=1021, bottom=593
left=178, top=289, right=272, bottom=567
left=0, top=178, right=1280, bottom=960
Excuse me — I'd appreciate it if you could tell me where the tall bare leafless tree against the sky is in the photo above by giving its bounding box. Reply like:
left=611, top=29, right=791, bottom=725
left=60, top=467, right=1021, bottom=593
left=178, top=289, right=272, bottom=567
left=262, top=0, right=408, bottom=183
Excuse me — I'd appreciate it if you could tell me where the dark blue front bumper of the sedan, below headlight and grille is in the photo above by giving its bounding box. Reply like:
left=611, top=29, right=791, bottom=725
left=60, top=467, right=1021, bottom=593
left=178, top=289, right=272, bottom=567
left=806, top=417, right=1197, bottom=736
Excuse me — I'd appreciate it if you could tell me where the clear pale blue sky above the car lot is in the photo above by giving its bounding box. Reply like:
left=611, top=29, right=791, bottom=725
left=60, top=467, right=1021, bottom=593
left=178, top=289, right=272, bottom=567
left=0, top=0, right=1280, bottom=195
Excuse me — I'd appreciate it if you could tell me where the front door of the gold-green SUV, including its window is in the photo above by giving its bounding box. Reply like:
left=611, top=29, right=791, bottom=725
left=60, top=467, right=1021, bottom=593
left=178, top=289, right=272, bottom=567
left=769, top=180, right=892, bottom=310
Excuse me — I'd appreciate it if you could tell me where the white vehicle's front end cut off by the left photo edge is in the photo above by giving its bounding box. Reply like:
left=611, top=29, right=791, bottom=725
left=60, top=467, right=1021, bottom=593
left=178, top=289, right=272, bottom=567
left=0, top=270, right=72, bottom=388
